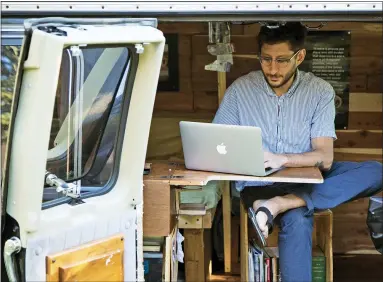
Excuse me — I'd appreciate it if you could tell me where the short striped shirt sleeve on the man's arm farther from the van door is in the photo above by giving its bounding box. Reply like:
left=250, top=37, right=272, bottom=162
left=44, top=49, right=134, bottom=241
left=311, top=85, right=337, bottom=140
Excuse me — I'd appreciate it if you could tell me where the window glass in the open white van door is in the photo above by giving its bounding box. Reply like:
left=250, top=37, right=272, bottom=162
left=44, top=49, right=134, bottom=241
left=43, top=47, right=130, bottom=202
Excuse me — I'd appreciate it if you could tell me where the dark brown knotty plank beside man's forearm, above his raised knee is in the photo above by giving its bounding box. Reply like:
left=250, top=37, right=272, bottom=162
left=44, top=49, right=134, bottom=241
left=334, top=130, right=383, bottom=148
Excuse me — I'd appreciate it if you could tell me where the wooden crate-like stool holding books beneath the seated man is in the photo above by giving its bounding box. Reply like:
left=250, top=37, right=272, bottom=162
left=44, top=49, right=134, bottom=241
left=240, top=201, right=333, bottom=282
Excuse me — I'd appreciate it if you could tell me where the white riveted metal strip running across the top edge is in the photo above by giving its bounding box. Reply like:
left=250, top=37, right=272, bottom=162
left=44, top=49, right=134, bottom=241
left=2, top=1, right=382, bottom=14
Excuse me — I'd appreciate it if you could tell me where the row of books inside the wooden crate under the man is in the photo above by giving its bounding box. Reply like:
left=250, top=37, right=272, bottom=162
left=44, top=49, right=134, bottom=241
left=248, top=240, right=326, bottom=282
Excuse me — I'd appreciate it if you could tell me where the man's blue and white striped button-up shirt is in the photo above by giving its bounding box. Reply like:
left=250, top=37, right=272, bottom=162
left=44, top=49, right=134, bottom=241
left=213, top=70, right=336, bottom=191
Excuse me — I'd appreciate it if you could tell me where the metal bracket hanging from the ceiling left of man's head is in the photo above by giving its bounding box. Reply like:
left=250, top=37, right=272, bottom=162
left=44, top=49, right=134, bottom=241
left=205, top=22, right=235, bottom=72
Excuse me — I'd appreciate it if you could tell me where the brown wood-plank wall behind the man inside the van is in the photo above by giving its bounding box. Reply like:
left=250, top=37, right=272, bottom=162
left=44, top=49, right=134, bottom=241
left=147, top=23, right=383, bottom=253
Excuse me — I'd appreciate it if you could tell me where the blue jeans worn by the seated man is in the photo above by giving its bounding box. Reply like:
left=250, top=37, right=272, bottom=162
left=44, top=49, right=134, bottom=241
left=241, top=161, right=383, bottom=282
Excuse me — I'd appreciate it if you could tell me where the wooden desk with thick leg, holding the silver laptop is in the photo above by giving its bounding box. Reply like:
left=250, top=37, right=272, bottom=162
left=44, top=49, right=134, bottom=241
left=143, top=162, right=323, bottom=282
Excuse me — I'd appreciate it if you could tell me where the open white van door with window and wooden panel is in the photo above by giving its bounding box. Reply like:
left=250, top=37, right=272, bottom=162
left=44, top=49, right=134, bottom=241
left=2, top=18, right=165, bottom=281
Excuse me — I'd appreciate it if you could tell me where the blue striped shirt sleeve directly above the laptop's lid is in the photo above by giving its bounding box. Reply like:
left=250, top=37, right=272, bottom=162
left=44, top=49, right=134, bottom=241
left=213, top=85, right=240, bottom=125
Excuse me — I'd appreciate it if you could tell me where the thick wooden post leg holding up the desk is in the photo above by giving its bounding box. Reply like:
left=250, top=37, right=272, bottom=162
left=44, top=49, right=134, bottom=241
left=184, top=229, right=211, bottom=282
